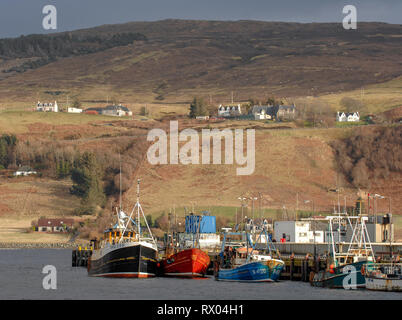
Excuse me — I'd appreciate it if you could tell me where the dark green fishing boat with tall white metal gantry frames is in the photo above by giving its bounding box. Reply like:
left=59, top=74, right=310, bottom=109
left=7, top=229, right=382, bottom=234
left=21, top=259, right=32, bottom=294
left=310, top=213, right=374, bottom=289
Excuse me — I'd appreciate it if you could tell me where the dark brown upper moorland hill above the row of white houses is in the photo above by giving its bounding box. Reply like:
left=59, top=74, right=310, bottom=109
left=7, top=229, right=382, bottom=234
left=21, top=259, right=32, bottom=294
left=0, top=20, right=402, bottom=105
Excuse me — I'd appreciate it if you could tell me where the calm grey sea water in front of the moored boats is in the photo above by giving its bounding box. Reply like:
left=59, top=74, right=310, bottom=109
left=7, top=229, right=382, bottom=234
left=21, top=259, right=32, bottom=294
left=0, top=249, right=402, bottom=300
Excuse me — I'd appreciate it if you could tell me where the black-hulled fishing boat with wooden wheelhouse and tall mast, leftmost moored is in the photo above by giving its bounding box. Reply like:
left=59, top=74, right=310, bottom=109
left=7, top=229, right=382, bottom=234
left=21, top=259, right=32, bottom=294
left=88, top=180, right=158, bottom=278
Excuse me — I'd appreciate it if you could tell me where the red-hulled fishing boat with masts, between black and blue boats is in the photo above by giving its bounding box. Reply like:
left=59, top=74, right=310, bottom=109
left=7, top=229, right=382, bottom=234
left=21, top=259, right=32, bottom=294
left=159, top=216, right=211, bottom=278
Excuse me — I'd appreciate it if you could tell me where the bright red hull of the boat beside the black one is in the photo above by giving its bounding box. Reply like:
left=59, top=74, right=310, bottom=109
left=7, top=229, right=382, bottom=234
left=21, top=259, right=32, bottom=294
left=160, top=249, right=211, bottom=278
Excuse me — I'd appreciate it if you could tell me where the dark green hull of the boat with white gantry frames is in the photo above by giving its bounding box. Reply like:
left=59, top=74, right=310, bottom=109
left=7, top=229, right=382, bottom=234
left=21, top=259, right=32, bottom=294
left=311, top=261, right=368, bottom=289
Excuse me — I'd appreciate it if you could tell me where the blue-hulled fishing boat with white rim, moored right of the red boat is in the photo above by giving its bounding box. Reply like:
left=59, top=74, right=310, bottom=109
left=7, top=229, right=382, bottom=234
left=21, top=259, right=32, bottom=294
left=214, top=225, right=285, bottom=282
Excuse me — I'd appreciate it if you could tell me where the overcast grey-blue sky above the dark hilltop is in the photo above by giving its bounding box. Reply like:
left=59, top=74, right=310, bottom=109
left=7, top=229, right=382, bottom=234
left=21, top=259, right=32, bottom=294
left=0, top=0, right=402, bottom=38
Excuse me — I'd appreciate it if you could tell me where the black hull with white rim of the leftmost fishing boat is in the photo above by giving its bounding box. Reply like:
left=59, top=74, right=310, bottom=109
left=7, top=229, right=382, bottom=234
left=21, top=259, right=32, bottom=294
left=88, top=243, right=157, bottom=278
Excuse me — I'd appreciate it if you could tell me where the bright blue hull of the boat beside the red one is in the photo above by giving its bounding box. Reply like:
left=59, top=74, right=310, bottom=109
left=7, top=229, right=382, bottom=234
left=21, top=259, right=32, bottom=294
left=215, top=259, right=284, bottom=282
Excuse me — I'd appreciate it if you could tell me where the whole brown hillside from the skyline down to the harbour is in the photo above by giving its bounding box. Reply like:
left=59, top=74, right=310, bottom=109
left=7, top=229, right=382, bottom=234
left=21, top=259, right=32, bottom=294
left=0, top=20, right=402, bottom=242
